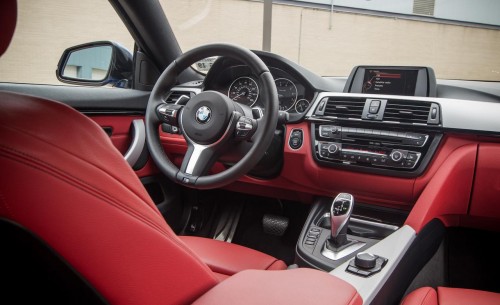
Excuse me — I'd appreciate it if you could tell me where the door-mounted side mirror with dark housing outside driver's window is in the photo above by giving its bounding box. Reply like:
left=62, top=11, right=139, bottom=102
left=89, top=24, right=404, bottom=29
left=56, top=41, right=133, bottom=88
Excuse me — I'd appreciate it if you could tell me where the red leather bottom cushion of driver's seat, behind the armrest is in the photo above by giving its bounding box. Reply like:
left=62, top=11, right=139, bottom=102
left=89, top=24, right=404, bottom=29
left=180, top=236, right=287, bottom=280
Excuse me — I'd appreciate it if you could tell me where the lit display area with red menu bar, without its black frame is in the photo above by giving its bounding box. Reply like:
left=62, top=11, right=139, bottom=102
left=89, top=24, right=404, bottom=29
left=362, top=69, right=418, bottom=96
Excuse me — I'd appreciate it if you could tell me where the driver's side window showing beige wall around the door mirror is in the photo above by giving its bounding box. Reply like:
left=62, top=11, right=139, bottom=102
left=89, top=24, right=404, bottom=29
left=0, top=0, right=134, bottom=85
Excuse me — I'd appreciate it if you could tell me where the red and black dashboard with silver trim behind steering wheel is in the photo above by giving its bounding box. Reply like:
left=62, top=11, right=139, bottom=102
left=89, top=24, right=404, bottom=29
left=160, top=51, right=500, bottom=210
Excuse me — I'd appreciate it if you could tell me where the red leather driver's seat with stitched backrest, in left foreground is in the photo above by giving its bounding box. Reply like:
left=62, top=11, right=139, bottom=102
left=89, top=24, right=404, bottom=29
left=0, top=0, right=286, bottom=304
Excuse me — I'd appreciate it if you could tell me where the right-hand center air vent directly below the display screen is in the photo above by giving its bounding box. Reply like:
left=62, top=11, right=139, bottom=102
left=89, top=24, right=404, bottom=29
left=383, top=100, right=431, bottom=125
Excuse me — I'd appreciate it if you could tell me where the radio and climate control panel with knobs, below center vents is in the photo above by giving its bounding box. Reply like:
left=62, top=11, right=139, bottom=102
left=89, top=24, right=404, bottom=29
left=312, top=123, right=441, bottom=176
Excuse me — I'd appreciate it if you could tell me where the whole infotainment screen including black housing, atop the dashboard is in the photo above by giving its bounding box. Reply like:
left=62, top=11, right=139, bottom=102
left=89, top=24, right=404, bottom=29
left=344, top=66, right=437, bottom=97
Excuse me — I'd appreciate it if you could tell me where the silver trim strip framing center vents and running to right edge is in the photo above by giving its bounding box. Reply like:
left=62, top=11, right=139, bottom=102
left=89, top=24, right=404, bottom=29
left=306, top=92, right=500, bottom=133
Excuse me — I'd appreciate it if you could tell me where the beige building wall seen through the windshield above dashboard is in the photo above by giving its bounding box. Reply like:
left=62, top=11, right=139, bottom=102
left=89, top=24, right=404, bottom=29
left=167, top=0, right=500, bottom=81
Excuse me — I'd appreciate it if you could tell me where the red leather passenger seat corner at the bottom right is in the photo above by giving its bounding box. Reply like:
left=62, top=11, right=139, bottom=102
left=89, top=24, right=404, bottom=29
left=401, top=287, right=500, bottom=305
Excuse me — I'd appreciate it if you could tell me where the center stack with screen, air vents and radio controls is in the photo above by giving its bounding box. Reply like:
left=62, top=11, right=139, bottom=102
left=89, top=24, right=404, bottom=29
left=307, top=66, right=441, bottom=177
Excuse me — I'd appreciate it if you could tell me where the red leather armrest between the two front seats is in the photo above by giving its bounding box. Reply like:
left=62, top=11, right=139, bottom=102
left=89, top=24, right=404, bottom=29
left=194, top=268, right=363, bottom=305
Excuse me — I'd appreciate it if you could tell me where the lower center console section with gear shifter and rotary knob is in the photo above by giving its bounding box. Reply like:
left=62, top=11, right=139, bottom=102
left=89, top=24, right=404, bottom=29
left=296, top=193, right=401, bottom=270
